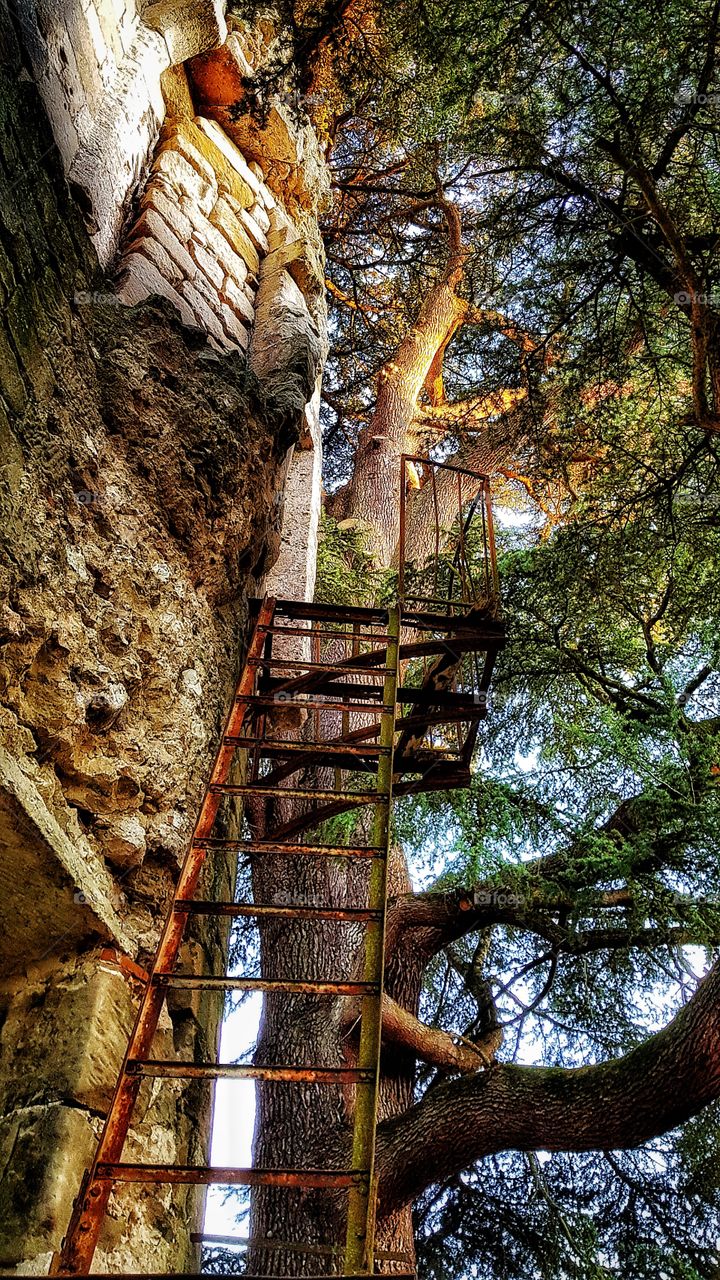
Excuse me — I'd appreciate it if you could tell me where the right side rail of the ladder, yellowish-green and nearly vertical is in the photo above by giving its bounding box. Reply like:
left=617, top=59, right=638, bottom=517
left=345, top=608, right=400, bottom=1275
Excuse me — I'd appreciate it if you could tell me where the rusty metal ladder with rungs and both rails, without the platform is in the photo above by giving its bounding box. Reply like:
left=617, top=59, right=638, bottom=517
left=51, top=598, right=400, bottom=1275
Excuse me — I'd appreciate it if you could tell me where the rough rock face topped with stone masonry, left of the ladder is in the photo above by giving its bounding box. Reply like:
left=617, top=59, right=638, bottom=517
left=0, top=0, right=327, bottom=1272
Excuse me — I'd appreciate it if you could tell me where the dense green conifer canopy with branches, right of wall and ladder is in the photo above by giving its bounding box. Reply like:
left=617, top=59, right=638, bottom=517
left=229, top=0, right=720, bottom=1280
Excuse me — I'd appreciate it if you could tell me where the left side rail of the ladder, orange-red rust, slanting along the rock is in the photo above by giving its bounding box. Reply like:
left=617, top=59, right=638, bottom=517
left=51, top=598, right=275, bottom=1275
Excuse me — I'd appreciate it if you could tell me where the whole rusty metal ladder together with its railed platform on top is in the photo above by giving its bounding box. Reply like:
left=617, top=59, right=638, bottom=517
left=51, top=460, right=505, bottom=1280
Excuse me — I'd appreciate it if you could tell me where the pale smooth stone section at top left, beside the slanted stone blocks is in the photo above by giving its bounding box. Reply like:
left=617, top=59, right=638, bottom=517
left=13, top=0, right=227, bottom=265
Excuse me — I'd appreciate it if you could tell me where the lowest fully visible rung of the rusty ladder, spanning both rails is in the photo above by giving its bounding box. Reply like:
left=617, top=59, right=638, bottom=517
left=95, top=1164, right=370, bottom=1189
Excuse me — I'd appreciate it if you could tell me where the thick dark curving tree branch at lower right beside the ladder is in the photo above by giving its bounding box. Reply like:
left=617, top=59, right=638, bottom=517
left=378, top=965, right=720, bottom=1215
